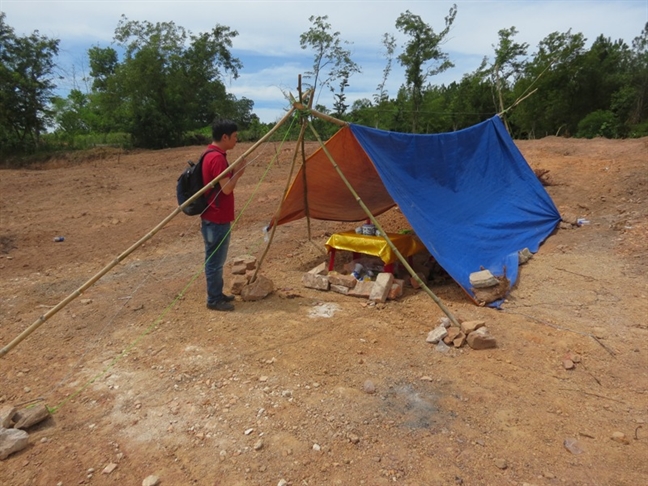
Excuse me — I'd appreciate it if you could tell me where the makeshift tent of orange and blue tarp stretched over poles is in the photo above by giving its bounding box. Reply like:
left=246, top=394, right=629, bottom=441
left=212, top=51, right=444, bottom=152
left=275, top=116, right=560, bottom=304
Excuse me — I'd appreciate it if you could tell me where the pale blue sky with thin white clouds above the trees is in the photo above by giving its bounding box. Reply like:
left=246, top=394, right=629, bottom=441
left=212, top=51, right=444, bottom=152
left=0, top=0, right=648, bottom=123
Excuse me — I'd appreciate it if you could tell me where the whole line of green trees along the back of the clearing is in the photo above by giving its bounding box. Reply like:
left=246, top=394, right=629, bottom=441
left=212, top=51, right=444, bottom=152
left=0, top=12, right=648, bottom=159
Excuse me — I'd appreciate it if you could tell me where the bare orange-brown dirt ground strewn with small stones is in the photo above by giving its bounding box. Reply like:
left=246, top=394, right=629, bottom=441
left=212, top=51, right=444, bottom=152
left=0, top=137, right=648, bottom=486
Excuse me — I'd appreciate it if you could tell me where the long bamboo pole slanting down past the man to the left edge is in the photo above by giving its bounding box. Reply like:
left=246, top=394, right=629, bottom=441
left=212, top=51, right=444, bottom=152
left=0, top=107, right=295, bottom=358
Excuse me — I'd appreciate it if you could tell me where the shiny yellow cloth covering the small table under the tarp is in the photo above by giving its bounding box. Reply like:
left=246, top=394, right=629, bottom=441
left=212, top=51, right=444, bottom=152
left=325, top=231, right=425, bottom=265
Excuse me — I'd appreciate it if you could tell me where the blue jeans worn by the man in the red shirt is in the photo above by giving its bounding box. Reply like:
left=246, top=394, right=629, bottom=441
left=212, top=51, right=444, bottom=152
left=200, top=219, right=230, bottom=305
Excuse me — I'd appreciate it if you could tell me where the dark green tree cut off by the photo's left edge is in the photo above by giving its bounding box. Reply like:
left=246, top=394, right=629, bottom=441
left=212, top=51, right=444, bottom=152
left=0, top=12, right=59, bottom=155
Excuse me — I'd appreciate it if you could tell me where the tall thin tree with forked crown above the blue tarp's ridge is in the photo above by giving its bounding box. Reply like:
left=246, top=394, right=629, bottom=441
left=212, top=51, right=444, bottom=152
left=396, top=5, right=457, bottom=133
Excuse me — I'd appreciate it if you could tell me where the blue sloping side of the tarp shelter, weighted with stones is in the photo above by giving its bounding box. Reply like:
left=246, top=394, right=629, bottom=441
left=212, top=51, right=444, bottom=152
left=350, top=116, right=560, bottom=302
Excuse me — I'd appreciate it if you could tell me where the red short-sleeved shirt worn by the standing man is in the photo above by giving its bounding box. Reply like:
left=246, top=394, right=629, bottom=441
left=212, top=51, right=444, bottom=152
left=201, top=145, right=234, bottom=224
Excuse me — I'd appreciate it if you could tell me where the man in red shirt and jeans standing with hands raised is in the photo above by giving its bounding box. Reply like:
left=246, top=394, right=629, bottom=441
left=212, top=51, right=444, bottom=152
left=201, top=119, right=244, bottom=311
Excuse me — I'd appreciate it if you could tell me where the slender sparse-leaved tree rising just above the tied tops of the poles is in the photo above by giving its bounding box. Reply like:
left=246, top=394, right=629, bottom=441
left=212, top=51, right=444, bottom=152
left=299, top=15, right=361, bottom=114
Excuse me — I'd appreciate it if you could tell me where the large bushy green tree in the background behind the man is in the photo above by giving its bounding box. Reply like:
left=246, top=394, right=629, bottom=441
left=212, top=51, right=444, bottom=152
left=88, top=16, right=244, bottom=148
